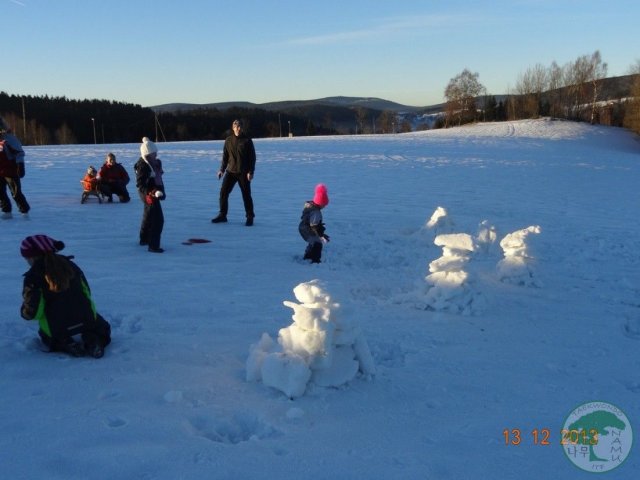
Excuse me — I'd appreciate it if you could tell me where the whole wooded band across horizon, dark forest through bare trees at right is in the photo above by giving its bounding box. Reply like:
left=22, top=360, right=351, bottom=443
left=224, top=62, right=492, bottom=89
left=0, top=51, right=640, bottom=145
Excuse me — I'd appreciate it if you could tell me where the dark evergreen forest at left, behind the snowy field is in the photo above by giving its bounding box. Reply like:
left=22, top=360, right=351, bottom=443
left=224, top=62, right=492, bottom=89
left=0, top=92, right=339, bottom=145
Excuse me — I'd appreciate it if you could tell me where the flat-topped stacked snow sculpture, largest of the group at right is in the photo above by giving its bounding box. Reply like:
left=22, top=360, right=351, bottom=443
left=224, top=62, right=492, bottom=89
left=425, top=233, right=479, bottom=315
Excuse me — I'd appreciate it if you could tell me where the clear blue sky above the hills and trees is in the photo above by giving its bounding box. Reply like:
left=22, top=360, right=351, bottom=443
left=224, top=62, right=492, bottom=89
left=6, top=0, right=640, bottom=106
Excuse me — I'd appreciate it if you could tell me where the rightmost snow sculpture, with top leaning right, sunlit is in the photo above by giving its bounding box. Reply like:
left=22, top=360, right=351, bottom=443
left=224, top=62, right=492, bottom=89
left=497, top=225, right=542, bottom=287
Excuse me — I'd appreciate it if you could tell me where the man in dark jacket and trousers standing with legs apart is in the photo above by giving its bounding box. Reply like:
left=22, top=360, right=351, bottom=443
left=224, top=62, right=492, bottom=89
left=211, top=120, right=256, bottom=227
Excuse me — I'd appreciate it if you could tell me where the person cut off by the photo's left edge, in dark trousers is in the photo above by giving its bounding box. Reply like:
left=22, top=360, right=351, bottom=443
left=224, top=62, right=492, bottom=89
left=0, top=118, right=31, bottom=219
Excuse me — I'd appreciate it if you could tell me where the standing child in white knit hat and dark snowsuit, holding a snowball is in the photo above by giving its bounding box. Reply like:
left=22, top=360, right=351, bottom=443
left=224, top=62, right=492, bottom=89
left=133, top=137, right=165, bottom=253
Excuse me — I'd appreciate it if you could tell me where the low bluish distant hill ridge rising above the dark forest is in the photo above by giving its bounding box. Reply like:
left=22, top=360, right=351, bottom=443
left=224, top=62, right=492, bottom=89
left=149, top=97, right=430, bottom=113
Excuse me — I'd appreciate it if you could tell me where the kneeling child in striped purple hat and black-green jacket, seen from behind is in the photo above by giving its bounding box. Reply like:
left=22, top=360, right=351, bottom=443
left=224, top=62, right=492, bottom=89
left=20, top=235, right=111, bottom=358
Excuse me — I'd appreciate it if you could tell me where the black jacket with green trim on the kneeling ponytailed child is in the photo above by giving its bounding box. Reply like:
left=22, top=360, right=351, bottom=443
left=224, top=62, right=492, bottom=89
left=20, top=257, right=96, bottom=339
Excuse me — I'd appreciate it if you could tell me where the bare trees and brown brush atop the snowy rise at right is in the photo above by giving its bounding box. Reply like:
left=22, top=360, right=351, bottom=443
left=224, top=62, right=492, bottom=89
left=438, top=50, right=640, bottom=133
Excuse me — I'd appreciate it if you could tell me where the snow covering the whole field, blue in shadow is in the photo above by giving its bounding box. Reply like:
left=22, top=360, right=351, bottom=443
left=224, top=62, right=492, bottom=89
left=0, top=119, right=640, bottom=479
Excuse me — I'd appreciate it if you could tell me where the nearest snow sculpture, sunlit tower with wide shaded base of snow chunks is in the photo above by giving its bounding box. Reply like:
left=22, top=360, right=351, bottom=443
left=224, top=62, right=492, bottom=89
left=246, top=280, right=375, bottom=398
